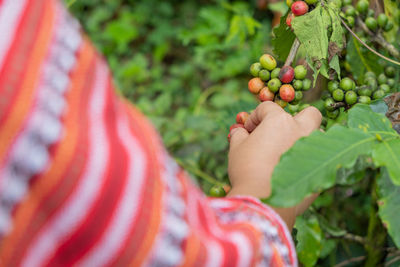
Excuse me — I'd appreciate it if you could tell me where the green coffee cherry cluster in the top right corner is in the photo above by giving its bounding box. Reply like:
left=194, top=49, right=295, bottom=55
left=340, top=0, right=394, bottom=32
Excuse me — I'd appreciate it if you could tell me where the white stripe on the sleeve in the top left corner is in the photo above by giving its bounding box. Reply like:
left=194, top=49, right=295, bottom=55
left=0, top=0, right=28, bottom=70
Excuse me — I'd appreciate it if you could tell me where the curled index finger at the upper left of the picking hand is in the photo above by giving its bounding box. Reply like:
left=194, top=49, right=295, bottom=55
left=244, top=101, right=285, bottom=132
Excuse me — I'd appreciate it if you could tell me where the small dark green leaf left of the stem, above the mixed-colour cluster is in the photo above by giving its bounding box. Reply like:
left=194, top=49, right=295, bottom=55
left=271, top=13, right=296, bottom=61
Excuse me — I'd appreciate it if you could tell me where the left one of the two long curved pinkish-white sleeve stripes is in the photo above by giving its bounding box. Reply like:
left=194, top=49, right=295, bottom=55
left=22, top=62, right=110, bottom=267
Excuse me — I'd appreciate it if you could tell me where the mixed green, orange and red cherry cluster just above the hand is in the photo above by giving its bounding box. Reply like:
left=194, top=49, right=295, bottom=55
left=248, top=54, right=311, bottom=113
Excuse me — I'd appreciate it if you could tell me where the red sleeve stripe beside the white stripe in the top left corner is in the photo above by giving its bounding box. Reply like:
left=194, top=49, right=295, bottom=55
left=0, top=0, right=45, bottom=126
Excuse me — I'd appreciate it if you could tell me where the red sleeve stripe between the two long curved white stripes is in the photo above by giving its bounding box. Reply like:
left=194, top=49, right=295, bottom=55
left=47, top=74, right=128, bottom=266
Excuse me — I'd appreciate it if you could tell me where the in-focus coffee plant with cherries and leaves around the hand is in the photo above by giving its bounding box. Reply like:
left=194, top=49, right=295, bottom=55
left=222, top=0, right=400, bottom=266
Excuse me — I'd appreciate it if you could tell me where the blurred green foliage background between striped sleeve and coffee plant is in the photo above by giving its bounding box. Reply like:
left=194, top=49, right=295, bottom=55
left=67, top=0, right=271, bottom=192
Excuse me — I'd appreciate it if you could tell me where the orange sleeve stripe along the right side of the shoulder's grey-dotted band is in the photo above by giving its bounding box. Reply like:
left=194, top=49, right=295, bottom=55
left=0, top=42, right=95, bottom=261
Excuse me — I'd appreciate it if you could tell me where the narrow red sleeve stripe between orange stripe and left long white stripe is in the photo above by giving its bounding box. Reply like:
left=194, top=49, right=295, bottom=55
left=11, top=54, right=95, bottom=266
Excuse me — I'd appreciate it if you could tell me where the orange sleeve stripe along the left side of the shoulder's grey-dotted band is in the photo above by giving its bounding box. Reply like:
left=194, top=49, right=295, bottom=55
left=0, top=1, right=55, bottom=159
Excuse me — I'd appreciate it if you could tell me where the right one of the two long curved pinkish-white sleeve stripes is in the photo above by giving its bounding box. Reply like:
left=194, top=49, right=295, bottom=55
left=78, top=112, right=146, bottom=267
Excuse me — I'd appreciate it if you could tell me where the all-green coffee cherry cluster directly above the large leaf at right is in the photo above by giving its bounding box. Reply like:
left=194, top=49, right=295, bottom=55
left=322, top=66, right=395, bottom=119
